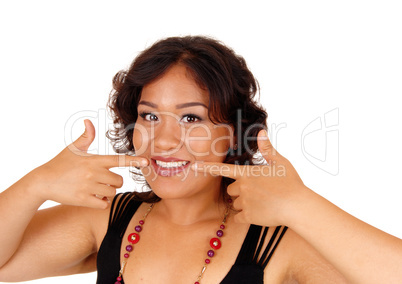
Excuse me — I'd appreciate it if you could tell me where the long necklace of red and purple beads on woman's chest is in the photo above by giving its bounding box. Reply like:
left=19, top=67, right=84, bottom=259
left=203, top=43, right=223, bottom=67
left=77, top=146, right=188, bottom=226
left=114, top=203, right=231, bottom=284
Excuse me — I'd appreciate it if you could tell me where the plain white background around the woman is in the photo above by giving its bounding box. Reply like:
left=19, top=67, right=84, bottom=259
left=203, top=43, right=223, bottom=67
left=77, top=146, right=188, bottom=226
left=0, top=0, right=402, bottom=284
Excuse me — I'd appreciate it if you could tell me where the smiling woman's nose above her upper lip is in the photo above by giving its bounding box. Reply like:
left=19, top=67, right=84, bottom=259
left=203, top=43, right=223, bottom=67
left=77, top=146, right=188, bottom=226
left=152, top=117, right=185, bottom=154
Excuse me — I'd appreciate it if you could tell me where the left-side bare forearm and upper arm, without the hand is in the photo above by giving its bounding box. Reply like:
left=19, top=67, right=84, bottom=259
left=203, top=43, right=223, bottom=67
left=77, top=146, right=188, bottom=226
left=0, top=168, right=108, bottom=282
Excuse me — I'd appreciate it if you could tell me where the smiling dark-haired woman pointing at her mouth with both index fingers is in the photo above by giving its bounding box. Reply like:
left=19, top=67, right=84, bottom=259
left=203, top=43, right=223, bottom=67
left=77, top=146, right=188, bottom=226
left=0, top=37, right=402, bottom=283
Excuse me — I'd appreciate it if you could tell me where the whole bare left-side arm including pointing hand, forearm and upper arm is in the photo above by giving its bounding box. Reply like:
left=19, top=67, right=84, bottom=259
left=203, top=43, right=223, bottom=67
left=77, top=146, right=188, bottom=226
left=0, top=121, right=147, bottom=281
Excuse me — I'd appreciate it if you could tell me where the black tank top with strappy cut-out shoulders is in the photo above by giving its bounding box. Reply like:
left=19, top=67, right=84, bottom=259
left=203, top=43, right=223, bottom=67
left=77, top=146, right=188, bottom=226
left=96, top=192, right=287, bottom=284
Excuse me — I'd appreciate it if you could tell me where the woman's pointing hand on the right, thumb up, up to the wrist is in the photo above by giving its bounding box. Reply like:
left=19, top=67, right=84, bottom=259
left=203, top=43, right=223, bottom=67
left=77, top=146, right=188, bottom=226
left=192, top=130, right=307, bottom=226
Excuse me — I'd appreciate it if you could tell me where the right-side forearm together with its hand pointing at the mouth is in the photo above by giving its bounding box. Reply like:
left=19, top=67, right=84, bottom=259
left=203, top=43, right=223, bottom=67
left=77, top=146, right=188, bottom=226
left=193, top=131, right=402, bottom=284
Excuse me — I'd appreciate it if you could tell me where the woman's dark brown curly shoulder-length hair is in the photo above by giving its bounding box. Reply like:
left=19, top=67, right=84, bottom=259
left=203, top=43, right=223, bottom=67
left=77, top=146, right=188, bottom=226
left=107, top=36, right=267, bottom=202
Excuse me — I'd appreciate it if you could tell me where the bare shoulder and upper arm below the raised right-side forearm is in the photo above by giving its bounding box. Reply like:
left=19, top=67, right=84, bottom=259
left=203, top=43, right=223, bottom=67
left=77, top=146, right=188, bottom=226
left=267, top=229, right=347, bottom=284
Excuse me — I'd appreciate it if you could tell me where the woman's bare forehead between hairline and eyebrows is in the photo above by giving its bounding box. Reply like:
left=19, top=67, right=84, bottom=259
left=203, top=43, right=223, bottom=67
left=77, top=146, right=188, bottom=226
left=141, top=64, right=209, bottom=107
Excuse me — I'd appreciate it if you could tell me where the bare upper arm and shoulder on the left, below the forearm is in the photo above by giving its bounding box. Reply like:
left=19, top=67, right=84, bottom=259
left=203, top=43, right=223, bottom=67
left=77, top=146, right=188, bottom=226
left=0, top=202, right=102, bottom=282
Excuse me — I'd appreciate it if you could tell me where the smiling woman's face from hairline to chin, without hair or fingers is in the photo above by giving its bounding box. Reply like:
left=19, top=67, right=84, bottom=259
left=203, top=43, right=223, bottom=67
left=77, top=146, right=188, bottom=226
left=133, top=65, right=233, bottom=199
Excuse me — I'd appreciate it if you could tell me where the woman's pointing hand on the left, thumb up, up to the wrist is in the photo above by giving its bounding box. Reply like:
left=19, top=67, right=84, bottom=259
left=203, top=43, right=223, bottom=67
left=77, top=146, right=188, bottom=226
left=27, top=120, right=148, bottom=209
